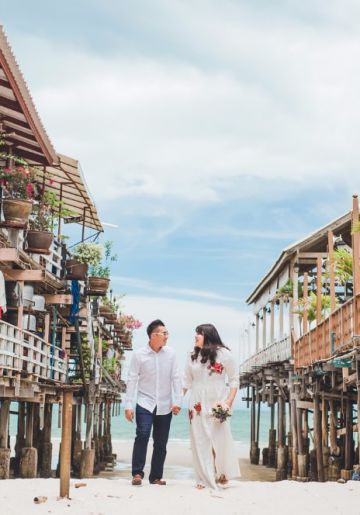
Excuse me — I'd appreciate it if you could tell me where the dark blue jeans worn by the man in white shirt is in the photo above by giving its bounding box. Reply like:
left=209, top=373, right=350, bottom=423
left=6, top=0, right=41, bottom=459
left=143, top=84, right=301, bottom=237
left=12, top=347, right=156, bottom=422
left=132, top=404, right=172, bottom=483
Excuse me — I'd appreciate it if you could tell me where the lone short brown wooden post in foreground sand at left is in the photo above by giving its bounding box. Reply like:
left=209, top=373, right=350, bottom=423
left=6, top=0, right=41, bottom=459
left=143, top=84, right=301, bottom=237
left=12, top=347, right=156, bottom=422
left=60, top=390, right=73, bottom=498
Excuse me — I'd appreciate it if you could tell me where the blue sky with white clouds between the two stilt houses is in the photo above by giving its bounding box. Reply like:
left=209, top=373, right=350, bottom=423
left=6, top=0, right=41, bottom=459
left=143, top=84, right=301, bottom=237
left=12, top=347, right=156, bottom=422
left=0, top=0, right=360, bottom=378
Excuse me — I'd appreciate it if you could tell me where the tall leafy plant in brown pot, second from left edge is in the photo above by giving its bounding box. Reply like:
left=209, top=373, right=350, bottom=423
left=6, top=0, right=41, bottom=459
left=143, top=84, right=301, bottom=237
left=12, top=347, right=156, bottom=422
left=26, top=190, right=74, bottom=254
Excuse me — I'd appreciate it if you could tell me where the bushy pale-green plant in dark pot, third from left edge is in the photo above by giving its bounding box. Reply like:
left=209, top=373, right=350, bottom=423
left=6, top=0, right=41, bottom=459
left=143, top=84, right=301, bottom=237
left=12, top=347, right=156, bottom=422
left=65, top=242, right=102, bottom=280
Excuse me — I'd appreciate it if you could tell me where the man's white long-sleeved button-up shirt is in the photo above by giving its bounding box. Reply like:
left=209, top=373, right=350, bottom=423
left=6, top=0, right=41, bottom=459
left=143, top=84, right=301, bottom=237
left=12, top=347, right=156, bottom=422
left=125, top=344, right=181, bottom=415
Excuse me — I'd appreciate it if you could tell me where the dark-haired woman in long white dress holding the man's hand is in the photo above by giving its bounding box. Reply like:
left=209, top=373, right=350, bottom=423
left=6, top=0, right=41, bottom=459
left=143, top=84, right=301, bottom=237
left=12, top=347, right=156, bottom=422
left=183, top=324, right=240, bottom=489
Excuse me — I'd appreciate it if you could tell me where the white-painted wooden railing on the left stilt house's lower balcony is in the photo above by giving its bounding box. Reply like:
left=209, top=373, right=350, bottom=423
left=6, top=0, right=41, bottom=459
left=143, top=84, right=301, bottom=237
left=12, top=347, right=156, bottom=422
left=0, top=321, right=67, bottom=383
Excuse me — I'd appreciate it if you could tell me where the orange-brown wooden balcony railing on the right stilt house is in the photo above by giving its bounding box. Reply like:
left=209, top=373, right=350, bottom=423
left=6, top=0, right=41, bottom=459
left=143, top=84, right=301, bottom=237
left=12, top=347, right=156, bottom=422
left=292, top=295, right=360, bottom=368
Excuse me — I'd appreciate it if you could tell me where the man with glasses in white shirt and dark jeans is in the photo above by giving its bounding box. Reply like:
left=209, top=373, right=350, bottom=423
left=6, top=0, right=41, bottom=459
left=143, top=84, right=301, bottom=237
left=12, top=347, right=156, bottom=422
left=125, top=320, right=181, bottom=485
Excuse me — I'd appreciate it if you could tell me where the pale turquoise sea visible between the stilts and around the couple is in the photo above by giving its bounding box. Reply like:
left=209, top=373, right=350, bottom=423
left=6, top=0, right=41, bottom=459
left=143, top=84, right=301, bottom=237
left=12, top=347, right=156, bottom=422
left=10, top=402, right=270, bottom=445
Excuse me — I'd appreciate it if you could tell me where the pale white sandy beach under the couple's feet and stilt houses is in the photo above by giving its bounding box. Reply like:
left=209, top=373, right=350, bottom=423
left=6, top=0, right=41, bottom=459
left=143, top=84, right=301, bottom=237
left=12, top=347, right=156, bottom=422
left=0, top=441, right=360, bottom=515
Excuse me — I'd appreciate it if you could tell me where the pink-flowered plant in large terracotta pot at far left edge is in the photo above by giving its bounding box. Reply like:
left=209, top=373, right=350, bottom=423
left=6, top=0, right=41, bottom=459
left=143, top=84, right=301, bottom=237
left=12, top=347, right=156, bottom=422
left=0, top=143, right=36, bottom=229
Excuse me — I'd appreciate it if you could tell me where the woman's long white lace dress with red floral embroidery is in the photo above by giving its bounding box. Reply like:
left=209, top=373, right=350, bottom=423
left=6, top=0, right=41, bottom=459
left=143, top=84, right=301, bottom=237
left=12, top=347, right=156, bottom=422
left=184, top=348, right=240, bottom=489
